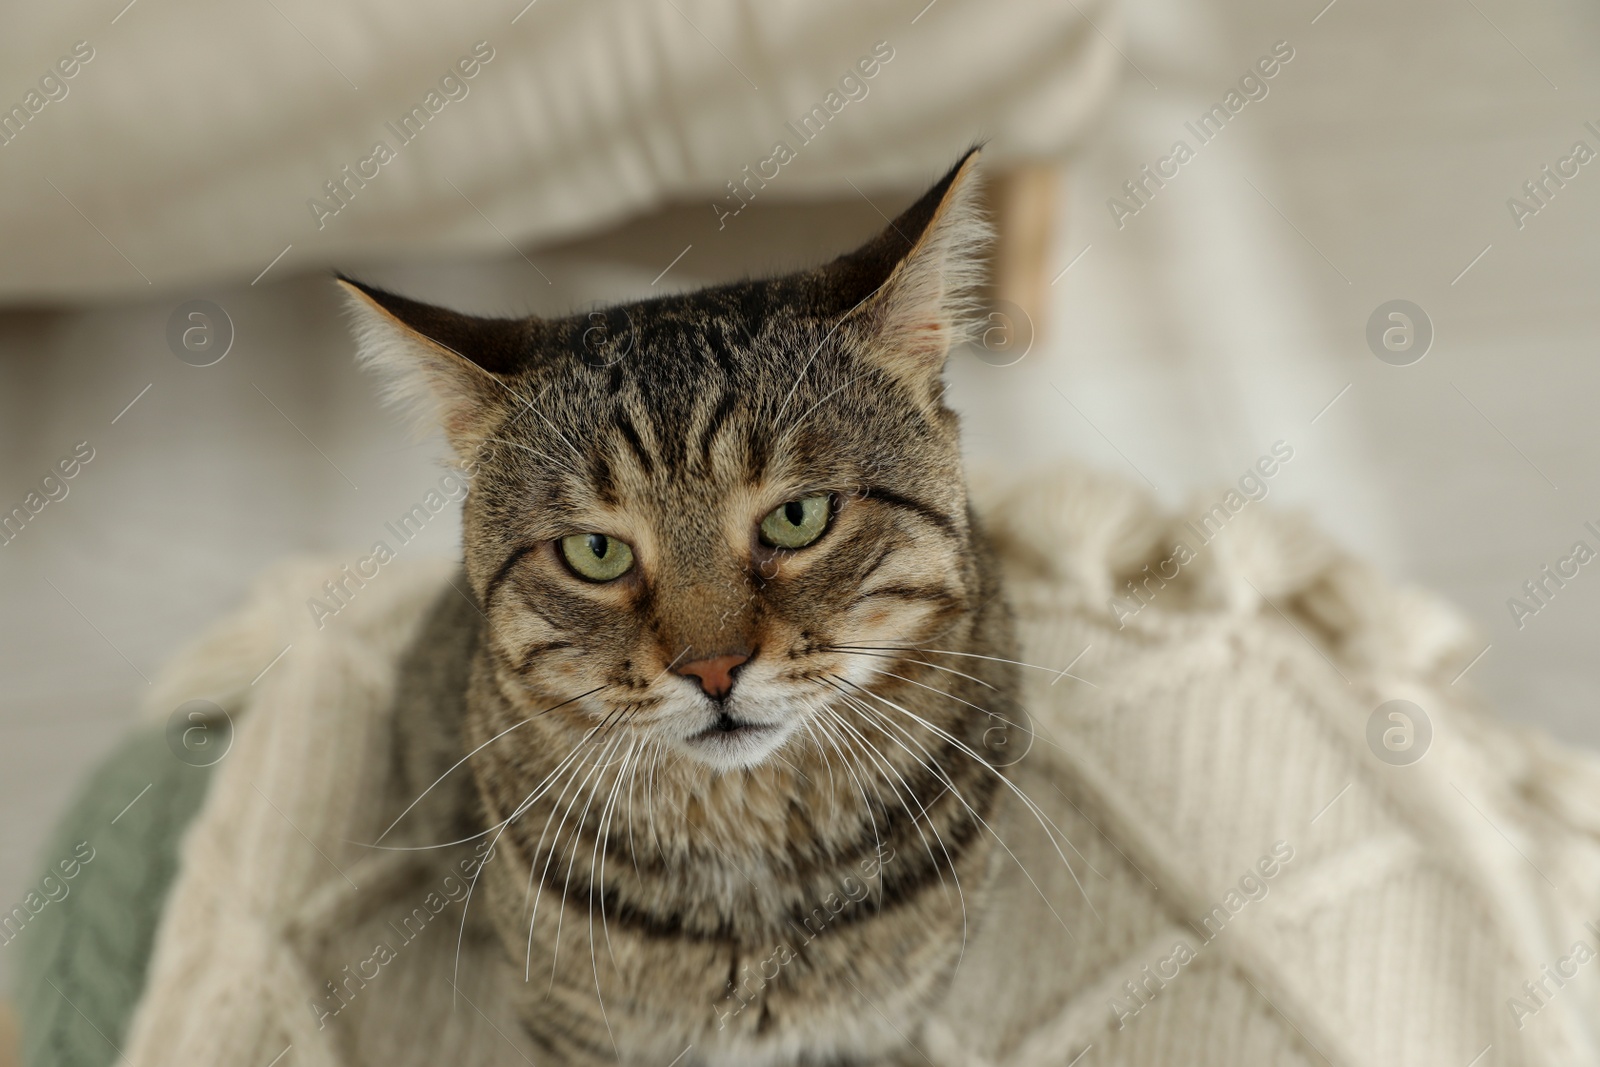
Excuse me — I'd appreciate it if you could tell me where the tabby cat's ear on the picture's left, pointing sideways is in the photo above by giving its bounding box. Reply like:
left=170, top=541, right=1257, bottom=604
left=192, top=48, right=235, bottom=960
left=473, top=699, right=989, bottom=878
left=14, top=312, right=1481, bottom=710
left=339, top=275, right=531, bottom=459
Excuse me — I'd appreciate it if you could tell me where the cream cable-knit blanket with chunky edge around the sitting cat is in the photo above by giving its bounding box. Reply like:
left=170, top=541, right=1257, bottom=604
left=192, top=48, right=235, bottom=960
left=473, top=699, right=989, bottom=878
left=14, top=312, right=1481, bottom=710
left=125, top=470, right=1600, bottom=1067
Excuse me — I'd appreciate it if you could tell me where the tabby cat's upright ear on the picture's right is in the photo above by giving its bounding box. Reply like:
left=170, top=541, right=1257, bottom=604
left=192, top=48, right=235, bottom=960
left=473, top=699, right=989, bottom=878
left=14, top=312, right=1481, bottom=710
left=838, top=149, right=990, bottom=392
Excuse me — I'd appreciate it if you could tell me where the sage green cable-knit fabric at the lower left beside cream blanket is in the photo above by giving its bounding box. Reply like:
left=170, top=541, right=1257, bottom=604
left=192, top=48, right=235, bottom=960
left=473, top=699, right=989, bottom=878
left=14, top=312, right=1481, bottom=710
left=12, top=728, right=211, bottom=1067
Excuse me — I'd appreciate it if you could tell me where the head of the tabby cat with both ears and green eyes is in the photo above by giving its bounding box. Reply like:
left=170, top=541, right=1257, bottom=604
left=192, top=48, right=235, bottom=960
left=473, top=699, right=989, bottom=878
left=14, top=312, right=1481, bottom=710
left=344, top=150, right=987, bottom=771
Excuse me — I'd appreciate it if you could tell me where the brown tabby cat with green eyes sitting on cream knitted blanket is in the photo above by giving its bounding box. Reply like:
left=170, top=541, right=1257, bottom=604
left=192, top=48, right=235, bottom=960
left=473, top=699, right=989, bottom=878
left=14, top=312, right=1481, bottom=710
left=346, top=152, right=1019, bottom=1067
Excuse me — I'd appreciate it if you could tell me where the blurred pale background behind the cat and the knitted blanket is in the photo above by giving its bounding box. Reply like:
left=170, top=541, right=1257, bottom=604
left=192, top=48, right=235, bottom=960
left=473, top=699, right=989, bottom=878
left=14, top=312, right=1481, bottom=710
left=0, top=0, right=1600, bottom=1011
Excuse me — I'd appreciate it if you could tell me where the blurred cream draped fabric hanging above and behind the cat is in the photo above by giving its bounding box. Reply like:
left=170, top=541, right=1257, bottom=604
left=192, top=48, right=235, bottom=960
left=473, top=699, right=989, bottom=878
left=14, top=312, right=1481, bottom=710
left=0, top=0, right=1122, bottom=302
